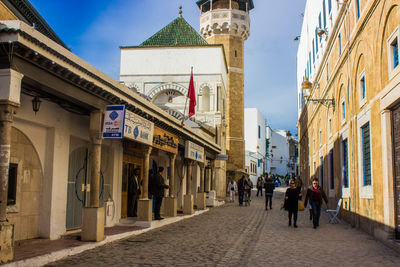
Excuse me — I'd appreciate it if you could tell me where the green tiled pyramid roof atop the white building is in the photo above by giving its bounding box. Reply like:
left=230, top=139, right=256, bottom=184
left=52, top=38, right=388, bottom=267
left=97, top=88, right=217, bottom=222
left=139, top=16, right=207, bottom=46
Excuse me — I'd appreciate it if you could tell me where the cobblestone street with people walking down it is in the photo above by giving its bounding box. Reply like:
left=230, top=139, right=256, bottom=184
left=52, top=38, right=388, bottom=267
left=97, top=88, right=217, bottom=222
left=48, top=189, right=400, bottom=267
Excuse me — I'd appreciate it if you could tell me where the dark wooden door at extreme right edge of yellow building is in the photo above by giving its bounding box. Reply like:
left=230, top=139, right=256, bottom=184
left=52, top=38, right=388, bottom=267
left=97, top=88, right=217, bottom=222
left=392, top=105, right=400, bottom=239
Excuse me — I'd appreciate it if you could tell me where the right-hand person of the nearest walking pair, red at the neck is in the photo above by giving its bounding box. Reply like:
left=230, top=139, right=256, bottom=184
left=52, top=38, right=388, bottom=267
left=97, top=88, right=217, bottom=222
left=304, top=178, right=328, bottom=229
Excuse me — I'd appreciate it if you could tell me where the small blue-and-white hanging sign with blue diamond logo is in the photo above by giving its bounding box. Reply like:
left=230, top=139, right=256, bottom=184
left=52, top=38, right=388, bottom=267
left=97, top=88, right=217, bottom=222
left=103, top=105, right=125, bottom=138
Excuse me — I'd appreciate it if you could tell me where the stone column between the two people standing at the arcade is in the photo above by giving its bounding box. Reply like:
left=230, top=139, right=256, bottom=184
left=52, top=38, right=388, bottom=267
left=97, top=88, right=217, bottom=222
left=138, top=146, right=153, bottom=223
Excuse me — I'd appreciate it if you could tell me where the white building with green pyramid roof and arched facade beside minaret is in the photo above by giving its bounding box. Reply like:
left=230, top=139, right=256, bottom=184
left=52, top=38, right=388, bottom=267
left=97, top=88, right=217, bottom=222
left=120, top=15, right=228, bottom=199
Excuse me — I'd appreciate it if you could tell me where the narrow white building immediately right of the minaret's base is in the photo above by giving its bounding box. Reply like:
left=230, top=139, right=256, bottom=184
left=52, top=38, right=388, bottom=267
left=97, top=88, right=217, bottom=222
left=244, top=108, right=266, bottom=184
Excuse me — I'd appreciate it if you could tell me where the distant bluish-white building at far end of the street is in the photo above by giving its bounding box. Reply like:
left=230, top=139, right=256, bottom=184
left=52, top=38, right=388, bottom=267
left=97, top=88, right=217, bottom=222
left=266, top=126, right=297, bottom=178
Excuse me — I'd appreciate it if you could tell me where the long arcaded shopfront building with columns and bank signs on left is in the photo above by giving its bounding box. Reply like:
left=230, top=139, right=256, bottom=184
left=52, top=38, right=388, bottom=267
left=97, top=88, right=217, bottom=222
left=0, top=0, right=222, bottom=263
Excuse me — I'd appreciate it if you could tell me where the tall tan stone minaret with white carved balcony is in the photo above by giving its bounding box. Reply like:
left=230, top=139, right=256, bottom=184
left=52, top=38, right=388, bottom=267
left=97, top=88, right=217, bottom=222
left=196, top=0, right=254, bottom=180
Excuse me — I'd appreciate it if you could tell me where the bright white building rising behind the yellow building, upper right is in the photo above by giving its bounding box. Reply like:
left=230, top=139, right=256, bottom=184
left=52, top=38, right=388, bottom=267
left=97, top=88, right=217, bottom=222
left=297, top=0, right=344, bottom=116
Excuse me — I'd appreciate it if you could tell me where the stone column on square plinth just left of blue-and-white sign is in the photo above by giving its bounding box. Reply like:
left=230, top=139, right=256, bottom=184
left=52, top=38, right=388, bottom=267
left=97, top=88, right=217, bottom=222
left=81, top=110, right=104, bottom=242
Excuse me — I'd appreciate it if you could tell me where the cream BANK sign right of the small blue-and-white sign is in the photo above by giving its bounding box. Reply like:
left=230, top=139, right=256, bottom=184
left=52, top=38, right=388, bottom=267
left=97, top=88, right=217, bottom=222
left=124, top=110, right=154, bottom=145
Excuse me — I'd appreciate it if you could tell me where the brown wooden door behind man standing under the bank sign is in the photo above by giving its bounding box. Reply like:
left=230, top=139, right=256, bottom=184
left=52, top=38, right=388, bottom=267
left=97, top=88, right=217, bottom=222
left=121, top=154, right=143, bottom=218
